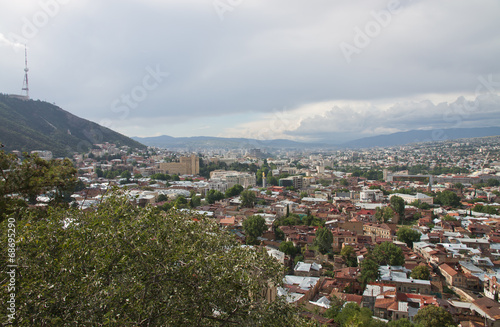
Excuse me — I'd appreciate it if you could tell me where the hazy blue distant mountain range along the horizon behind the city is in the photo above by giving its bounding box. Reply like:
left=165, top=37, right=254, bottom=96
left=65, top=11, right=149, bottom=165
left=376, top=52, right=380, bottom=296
left=132, top=127, right=500, bottom=150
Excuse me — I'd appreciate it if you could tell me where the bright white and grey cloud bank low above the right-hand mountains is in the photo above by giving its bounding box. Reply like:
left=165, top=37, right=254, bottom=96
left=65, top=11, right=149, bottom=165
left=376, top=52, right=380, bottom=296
left=286, top=94, right=500, bottom=141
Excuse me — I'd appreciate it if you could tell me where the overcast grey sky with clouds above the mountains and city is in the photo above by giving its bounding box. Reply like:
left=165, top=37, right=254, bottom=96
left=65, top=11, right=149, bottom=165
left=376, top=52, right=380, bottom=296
left=0, top=0, right=500, bottom=142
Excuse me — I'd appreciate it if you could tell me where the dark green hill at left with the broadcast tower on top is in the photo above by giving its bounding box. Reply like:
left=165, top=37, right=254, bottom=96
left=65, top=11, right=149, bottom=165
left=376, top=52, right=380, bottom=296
left=0, top=94, right=145, bottom=157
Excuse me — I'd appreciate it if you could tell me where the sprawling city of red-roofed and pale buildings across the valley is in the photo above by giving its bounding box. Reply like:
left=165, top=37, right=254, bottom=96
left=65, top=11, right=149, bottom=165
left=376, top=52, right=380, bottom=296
left=2, top=137, right=500, bottom=326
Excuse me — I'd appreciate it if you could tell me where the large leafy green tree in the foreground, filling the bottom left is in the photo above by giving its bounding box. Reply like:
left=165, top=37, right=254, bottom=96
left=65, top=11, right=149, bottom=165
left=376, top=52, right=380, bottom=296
left=0, top=196, right=312, bottom=326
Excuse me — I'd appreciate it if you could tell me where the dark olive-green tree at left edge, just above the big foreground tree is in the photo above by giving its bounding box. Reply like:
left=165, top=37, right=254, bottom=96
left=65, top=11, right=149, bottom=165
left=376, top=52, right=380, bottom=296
left=0, top=151, right=78, bottom=220
